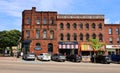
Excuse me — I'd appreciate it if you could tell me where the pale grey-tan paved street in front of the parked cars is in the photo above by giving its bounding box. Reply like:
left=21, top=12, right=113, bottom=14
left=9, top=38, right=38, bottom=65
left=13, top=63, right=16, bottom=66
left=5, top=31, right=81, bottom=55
left=0, top=57, right=120, bottom=73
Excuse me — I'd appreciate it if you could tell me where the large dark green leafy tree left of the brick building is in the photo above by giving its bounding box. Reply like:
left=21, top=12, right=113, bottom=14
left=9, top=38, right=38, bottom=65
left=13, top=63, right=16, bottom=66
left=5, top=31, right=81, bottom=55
left=0, top=30, right=21, bottom=54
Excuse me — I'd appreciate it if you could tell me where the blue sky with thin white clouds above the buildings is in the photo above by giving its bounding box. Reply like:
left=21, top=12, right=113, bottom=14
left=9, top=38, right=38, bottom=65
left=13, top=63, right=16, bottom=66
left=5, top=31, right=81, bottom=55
left=0, top=0, right=120, bottom=31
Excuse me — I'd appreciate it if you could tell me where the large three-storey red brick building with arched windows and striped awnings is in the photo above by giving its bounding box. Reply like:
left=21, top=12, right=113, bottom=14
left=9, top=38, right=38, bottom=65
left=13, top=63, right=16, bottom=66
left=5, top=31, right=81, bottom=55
left=22, top=7, right=119, bottom=55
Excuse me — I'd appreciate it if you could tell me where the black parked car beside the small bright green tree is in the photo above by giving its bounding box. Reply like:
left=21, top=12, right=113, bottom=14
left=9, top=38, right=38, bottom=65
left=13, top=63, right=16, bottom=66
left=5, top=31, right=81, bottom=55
left=91, top=55, right=111, bottom=64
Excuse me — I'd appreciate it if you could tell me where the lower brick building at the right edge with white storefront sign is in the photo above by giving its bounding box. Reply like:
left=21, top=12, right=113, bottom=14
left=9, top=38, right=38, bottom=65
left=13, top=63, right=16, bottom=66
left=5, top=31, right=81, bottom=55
left=104, top=24, right=120, bottom=54
